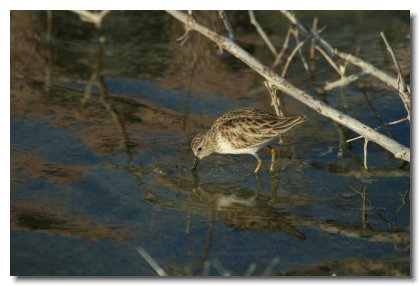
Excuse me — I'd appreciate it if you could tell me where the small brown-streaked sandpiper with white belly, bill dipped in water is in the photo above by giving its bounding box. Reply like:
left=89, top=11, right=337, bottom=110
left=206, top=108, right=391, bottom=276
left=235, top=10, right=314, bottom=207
left=191, top=108, right=307, bottom=174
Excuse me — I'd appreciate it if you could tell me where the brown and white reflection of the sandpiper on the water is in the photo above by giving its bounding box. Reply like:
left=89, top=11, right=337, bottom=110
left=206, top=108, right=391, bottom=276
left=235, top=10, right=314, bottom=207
left=145, top=172, right=305, bottom=240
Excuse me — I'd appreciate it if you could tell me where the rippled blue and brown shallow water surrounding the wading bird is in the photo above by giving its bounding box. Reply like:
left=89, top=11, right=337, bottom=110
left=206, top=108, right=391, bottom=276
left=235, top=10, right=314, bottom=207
left=11, top=11, right=411, bottom=276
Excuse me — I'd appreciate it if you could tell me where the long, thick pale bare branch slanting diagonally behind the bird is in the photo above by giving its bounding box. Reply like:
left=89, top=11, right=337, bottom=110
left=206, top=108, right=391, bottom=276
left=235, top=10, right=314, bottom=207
left=167, top=11, right=410, bottom=162
